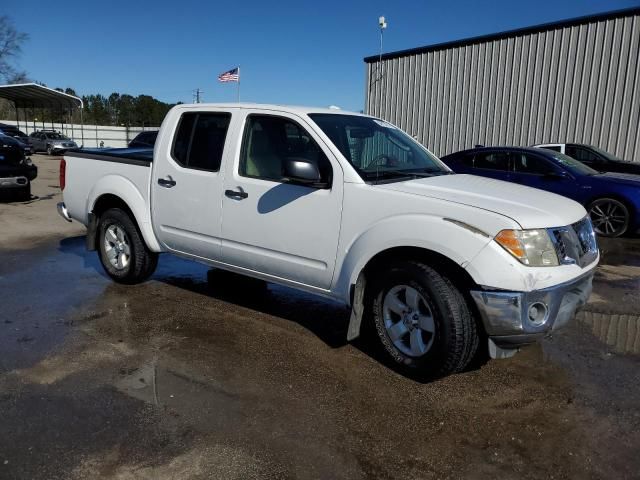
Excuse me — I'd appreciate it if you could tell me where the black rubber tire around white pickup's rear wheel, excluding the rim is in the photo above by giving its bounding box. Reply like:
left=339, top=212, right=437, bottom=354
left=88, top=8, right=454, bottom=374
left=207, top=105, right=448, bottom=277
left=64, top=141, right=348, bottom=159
left=97, top=208, right=158, bottom=285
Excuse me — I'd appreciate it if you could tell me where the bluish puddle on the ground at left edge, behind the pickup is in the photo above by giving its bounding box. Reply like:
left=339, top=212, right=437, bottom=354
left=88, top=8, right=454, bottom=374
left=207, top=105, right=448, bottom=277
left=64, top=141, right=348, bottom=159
left=0, top=239, right=107, bottom=371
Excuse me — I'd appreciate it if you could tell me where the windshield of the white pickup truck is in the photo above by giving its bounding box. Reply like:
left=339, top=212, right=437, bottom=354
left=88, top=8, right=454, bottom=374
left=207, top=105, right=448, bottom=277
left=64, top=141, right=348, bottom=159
left=309, top=113, right=452, bottom=181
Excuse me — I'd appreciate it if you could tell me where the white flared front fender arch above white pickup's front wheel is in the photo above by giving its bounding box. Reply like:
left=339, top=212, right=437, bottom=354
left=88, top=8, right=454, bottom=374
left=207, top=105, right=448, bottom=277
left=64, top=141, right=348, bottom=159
left=332, top=214, right=491, bottom=304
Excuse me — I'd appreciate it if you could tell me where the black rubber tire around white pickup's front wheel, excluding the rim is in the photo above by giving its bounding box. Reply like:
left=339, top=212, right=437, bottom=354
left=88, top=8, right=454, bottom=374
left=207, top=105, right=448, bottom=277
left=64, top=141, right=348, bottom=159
left=367, top=261, right=480, bottom=378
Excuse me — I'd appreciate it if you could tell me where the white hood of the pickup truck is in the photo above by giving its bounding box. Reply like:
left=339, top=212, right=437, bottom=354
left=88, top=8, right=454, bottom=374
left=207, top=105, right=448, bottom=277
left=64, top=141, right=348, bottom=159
left=378, top=174, right=587, bottom=229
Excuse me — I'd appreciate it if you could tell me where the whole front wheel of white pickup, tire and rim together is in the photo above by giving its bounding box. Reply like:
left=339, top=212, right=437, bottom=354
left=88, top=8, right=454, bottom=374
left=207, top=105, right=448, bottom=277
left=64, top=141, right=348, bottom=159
left=369, top=261, right=479, bottom=377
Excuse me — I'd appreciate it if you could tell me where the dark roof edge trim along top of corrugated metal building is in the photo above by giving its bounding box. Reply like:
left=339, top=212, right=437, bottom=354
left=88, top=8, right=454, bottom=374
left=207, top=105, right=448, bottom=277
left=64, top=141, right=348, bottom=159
left=364, top=7, right=640, bottom=63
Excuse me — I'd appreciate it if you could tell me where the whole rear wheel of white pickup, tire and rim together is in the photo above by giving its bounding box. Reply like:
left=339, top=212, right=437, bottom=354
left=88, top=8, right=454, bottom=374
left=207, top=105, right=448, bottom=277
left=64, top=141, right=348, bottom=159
left=98, top=208, right=158, bottom=284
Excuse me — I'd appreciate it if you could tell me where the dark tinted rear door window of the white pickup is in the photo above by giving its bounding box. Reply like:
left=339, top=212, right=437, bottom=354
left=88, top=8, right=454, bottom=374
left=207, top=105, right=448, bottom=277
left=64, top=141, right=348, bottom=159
left=172, top=112, right=231, bottom=172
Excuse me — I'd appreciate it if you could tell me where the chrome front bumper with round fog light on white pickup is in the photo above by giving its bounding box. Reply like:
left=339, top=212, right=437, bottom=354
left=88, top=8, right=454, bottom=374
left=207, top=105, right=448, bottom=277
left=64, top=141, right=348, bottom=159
left=471, top=269, right=595, bottom=356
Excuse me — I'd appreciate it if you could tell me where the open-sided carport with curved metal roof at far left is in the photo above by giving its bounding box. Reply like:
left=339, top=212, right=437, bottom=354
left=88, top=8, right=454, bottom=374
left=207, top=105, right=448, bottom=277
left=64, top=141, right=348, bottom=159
left=0, top=83, right=84, bottom=146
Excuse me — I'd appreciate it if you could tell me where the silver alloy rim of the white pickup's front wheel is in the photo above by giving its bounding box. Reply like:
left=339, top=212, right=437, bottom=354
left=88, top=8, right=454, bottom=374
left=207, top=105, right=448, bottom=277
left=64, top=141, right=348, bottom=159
left=382, top=285, right=435, bottom=357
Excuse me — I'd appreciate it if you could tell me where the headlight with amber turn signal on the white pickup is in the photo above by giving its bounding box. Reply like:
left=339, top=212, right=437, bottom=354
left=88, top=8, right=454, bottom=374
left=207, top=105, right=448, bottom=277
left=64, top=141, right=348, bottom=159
left=494, top=228, right=559, bottom=267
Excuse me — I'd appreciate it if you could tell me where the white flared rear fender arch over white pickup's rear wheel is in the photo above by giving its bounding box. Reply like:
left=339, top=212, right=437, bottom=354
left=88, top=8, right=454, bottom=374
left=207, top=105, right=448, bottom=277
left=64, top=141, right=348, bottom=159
left=85, top=174, right=162, bottom=252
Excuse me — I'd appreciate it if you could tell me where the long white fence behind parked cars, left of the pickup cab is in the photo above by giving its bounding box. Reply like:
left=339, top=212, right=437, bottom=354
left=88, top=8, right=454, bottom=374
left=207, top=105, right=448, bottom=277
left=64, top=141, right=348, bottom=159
left=0, top=120, right=158, bottom=148
